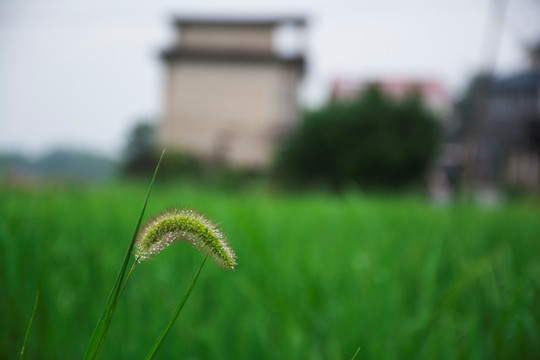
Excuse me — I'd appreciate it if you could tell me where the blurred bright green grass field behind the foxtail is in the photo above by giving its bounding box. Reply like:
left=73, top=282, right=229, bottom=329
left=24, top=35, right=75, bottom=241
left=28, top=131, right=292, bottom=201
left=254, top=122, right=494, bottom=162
left=0, top=184, right=540, bottom=359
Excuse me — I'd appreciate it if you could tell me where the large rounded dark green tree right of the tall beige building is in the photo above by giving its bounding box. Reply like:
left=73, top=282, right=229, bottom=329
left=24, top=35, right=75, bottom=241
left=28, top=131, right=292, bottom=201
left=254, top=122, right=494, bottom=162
left=276, top=88, right=438, bottom=189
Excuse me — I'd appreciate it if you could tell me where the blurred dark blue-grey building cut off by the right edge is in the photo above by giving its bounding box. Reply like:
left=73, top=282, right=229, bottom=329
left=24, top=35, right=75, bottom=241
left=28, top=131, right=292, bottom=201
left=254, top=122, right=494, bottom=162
left=465, top=42, right=540, bottom=189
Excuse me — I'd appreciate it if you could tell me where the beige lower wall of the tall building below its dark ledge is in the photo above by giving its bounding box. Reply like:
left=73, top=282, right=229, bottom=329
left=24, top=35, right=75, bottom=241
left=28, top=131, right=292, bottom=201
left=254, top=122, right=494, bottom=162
left=159, top=61, right=299, bottom=168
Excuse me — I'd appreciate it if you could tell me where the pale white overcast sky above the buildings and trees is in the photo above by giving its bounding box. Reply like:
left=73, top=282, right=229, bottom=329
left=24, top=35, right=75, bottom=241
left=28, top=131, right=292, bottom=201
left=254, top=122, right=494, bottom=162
left=0, top=0, right=540, bottom=156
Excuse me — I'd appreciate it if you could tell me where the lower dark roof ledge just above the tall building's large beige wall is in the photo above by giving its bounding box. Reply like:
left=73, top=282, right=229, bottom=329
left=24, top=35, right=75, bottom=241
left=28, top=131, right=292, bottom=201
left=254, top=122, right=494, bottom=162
left=160, top=47, right=305, bottom=71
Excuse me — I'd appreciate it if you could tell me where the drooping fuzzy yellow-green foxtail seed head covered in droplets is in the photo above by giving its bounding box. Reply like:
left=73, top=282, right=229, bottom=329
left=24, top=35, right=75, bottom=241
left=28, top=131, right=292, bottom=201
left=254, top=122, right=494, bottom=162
left=134, top=209, right=236, bottom=270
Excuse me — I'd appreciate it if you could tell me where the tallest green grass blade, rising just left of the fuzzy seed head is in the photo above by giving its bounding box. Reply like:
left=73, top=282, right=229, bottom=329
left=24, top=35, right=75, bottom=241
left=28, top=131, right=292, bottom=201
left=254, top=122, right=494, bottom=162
left=84, top=150, right=165, bottom=360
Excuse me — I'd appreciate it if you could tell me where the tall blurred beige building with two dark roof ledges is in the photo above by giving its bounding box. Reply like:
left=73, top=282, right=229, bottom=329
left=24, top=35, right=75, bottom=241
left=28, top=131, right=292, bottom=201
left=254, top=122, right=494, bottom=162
left=158, top=16, right=306, bottom=169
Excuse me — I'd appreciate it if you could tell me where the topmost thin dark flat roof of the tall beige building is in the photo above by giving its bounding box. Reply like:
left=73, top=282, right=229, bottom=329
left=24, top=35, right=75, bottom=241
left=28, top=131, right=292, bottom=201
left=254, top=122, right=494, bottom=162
left=174, top=15, right=307, bottom=27
